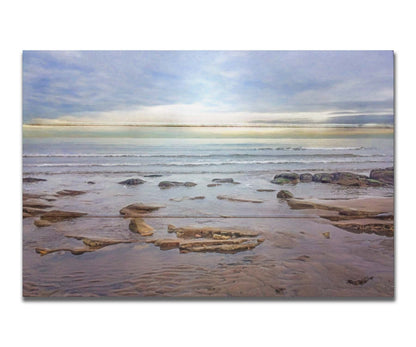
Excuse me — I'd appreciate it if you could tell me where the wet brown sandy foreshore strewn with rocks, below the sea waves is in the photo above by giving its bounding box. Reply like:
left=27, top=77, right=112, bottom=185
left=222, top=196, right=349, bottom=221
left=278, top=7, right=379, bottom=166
left=23, top=163, right=394, bottom=298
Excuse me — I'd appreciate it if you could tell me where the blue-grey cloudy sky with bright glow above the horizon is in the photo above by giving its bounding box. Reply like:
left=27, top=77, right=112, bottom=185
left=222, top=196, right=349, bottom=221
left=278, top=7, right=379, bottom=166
left=23, top=51, right=393, bottom=125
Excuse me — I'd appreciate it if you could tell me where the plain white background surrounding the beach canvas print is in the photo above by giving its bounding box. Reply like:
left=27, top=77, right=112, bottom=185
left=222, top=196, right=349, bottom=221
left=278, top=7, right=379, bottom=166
left=0, top=0, right=416, bottom=347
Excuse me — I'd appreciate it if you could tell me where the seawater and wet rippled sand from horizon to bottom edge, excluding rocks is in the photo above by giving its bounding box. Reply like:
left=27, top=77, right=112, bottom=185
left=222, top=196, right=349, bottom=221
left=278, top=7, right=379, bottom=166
left=22, top=127, right=394, bottom=296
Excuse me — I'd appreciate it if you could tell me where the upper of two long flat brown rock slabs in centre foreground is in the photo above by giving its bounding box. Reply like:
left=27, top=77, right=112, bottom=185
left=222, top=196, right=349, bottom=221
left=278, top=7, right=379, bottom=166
left=168, top=224, right=258, bottom=238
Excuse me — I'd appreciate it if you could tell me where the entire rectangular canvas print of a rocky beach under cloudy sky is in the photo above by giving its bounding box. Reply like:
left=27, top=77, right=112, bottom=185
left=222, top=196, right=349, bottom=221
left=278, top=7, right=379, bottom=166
left=22, top=51, right=395, bottom=299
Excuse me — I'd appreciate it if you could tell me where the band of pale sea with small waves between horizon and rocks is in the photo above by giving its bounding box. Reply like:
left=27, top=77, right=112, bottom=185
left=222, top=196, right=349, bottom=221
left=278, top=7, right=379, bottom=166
left=23, top=127, right=394, bottom=176
